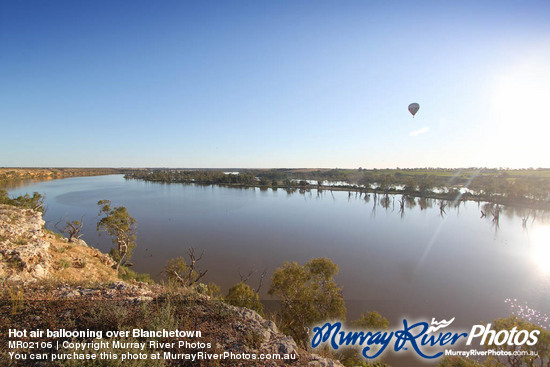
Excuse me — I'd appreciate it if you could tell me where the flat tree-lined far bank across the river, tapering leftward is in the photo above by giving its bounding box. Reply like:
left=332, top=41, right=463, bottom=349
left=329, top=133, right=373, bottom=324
left=125, top=168, right=550, bottom=209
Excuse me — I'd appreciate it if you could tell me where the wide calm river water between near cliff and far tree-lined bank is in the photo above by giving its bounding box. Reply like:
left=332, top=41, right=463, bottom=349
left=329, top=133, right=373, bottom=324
left=4, top=175, right=550, bottom=326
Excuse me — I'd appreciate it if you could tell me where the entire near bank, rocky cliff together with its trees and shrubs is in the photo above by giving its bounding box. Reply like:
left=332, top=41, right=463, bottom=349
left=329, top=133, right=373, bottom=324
left=0, top=191, right=550, bottom=367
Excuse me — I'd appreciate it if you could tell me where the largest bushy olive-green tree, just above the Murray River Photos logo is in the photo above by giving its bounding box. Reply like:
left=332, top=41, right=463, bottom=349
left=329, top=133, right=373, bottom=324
left=269, top=258, right=346, bottom=347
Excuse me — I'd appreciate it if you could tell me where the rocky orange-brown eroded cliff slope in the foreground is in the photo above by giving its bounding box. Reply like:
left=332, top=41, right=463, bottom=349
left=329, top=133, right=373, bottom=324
left=0, top=205, right=342, bottom=366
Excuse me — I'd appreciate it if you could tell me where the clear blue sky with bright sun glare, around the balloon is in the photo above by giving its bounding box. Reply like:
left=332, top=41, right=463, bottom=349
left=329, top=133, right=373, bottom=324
left=0, top=0, right=550, bottom=168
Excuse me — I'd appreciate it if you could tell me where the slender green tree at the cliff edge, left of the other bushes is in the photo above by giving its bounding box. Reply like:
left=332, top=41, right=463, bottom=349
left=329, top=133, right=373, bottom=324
left=97, top=200, right=137, bottom=272
